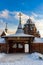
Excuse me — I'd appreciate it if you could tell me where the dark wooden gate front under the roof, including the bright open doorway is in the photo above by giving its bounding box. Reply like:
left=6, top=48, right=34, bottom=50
left=7, top=40, right=29, bottom=53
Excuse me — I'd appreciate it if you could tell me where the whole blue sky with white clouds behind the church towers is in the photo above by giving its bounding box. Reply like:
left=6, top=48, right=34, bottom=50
left=0, top=0, right=43, bottom=35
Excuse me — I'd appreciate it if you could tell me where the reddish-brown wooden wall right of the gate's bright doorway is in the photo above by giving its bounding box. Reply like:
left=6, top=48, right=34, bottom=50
left=30, top=43, right=43, bottom=53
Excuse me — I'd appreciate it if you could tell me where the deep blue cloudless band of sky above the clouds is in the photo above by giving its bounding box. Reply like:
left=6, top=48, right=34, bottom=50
left=0, top=0, right=43, bottom=13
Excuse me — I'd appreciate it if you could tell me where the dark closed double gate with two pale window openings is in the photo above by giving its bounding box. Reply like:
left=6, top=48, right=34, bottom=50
left=9, top=43, right=24, bottom=53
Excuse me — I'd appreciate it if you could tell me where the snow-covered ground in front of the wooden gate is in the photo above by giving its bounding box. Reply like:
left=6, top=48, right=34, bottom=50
left=0, top=52, right=43, bottom=65
